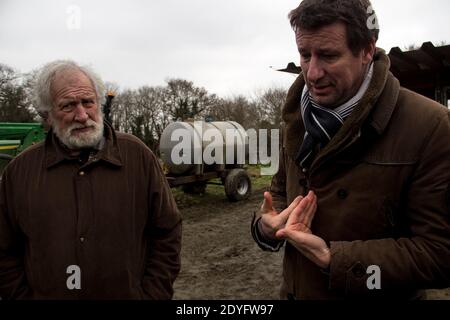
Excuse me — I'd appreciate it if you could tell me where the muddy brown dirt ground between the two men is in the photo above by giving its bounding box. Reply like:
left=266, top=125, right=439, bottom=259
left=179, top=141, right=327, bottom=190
left=174, top=190, right=450, bottom=300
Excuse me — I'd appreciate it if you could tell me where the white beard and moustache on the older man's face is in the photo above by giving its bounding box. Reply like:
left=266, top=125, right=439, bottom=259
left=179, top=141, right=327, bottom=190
left=52, top=112, right=104, bottom=149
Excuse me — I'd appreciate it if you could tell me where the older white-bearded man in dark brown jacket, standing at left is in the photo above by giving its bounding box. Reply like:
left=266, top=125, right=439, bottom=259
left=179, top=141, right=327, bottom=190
left=0, top=61, right=181, bottom=299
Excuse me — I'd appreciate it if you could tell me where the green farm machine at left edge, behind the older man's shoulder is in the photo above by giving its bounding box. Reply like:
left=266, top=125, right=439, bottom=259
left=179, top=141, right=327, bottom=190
left=0, top=123, right=46, bottom=173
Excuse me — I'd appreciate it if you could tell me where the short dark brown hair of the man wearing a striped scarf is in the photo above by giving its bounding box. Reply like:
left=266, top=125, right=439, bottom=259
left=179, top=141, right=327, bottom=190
left=289, top=0, right=380, bottom=55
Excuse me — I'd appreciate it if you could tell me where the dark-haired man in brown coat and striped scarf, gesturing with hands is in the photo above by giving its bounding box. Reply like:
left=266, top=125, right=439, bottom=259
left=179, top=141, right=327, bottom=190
left=252, top=0, right=450, bottom=299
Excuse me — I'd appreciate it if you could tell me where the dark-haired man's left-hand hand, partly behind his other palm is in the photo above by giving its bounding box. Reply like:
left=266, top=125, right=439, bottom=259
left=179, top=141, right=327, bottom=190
left=259, top=192, right=303, bottom=240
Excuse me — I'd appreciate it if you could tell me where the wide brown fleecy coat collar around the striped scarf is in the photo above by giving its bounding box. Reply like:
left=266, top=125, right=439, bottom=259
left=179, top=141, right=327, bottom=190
left=282, top=48, right=400, bottom=162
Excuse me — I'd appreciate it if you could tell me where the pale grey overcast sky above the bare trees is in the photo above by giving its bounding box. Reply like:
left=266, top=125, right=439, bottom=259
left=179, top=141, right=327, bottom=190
left=0, top=0, right=450, bottom=97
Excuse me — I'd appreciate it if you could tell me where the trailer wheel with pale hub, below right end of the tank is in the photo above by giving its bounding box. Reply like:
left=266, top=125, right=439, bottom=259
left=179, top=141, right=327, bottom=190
left=225, top=169, right=252, bottom=202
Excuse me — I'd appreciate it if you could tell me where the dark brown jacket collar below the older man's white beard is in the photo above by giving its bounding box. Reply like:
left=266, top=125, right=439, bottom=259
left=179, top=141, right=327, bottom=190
left=45, top=121, right=122, bottom=169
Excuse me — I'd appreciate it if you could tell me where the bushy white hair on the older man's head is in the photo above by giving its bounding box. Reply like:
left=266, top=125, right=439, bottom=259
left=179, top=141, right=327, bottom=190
left=34, top=60, right=106, bottom=116
